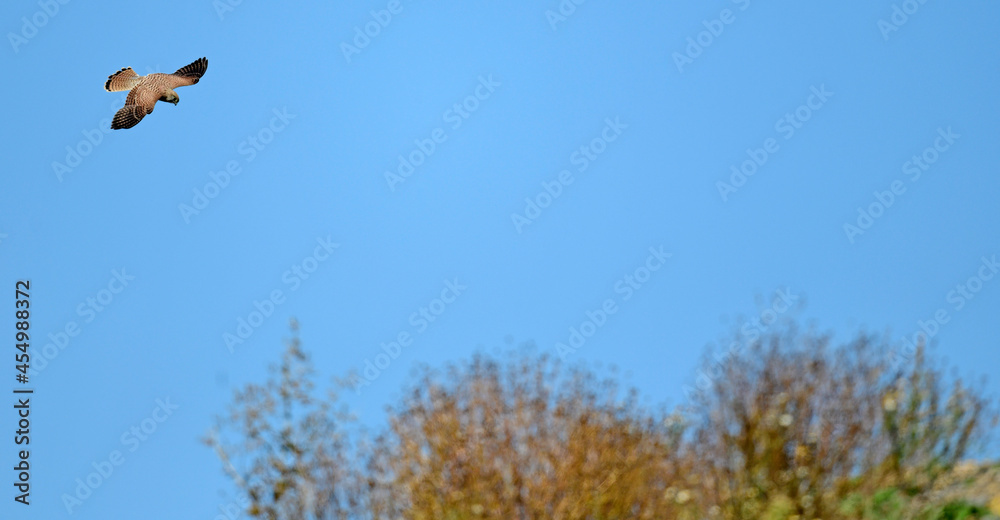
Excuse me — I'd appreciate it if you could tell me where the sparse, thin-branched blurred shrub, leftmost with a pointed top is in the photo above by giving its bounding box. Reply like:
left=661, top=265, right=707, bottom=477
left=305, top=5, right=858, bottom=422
left=203, top=320, right=365, bottom=520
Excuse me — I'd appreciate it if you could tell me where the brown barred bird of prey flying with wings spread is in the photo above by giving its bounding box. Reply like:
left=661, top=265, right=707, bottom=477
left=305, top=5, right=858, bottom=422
left=104, top=58, right=208, bottom=130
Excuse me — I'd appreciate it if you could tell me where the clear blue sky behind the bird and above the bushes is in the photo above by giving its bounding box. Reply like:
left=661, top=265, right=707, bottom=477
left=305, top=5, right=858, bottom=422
left=0, top=0, right=1000, bottom=519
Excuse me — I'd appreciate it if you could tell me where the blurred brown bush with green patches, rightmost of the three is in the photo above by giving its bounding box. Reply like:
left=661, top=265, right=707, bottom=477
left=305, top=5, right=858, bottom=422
left=692, top=326, right=997, bottom=519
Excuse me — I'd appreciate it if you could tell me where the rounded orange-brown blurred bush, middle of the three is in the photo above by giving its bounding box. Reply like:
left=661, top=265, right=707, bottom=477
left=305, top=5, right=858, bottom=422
left=364, top=355, right=694, bottom=520
